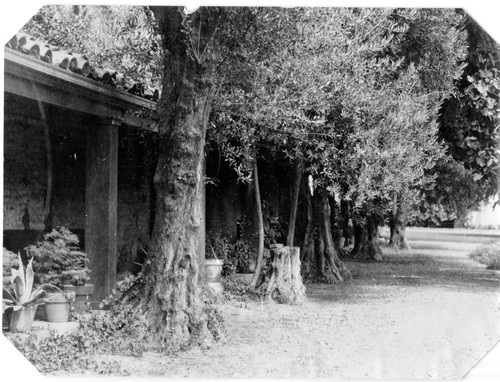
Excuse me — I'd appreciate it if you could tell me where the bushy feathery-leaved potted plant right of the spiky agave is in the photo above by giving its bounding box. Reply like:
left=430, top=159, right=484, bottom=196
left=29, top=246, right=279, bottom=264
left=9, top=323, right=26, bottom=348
left=26, top=227, right=94, bottom=313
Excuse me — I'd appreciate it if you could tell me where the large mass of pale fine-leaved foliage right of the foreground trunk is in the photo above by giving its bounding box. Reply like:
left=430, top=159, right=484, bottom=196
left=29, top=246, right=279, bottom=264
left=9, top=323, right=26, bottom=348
left=211, top=8, right=465, bottom=224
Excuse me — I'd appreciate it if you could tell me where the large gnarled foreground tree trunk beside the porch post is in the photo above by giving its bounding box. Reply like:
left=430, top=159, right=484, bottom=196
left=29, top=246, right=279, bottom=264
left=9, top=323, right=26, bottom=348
left=139, top=7, right=221, bottom=350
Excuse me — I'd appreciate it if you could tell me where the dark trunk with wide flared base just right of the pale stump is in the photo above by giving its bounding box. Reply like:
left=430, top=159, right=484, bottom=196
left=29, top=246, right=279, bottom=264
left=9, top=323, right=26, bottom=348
left=303, top=188, right=351, bottom=283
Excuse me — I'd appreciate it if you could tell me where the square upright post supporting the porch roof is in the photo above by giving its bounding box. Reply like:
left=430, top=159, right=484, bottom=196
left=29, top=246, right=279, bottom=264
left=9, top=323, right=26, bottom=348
left=85, top=119, right=121, bottom=301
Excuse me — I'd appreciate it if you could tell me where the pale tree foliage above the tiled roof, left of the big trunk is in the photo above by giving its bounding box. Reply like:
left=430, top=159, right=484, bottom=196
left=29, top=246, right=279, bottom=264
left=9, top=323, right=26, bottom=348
left=23, top=5, right=163, bottom=89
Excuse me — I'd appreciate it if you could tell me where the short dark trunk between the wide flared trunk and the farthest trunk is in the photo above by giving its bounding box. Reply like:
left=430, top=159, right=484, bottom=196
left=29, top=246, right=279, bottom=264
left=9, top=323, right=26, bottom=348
left=351, top=215, right=382, bottom=261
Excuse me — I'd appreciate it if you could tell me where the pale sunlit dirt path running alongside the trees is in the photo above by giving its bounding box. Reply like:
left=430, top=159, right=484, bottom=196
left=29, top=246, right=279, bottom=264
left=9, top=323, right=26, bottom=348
left=91, top=237, right=500, bottom=379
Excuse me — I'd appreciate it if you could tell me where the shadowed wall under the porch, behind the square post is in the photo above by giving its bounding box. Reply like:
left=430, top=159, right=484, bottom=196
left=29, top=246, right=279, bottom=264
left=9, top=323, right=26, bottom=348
left=3, top=112, right=152, bottom=271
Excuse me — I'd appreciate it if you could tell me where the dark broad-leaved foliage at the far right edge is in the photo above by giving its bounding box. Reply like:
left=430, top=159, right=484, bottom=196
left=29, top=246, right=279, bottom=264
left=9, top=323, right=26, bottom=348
left=415, top=16, right=500, bottom=224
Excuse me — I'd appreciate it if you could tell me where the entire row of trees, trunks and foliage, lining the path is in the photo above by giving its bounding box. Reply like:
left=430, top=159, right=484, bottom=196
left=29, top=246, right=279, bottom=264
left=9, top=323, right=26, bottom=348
left=21, top=7, right=498, bottom=348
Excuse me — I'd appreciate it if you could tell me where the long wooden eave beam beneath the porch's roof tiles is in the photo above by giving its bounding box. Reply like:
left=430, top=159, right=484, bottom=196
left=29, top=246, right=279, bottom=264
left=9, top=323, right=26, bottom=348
left=4, top=48, right=156, bottom=130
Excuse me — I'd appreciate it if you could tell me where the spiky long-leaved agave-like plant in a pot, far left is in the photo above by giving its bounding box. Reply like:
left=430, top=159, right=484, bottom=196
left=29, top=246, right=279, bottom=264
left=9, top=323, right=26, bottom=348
left=2, top=255, right=58, bottom=332
